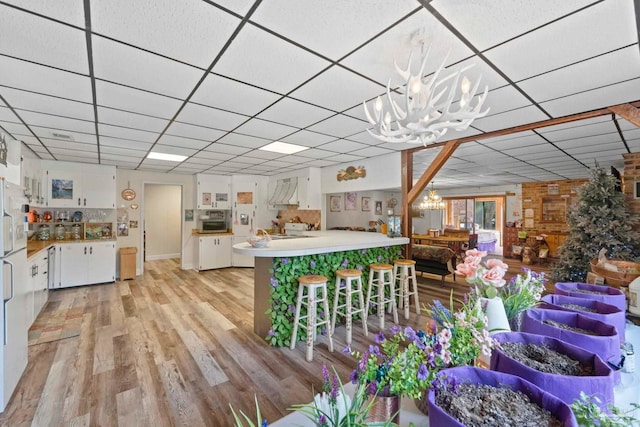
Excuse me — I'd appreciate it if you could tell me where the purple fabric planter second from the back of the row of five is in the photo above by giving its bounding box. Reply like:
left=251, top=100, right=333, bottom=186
left=538, top=294, right=627, bottom=342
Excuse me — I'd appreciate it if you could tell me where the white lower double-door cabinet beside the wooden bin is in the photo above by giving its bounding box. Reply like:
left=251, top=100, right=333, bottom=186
left=54, top=242, right=116, bottom=288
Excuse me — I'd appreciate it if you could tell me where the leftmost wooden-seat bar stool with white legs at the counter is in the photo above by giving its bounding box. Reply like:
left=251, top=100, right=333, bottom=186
left=290, top=275, right=333, bottom=362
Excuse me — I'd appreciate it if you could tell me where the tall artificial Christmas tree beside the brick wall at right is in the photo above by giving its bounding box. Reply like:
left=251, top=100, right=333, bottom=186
left=552, top=164, right=640, bottom=282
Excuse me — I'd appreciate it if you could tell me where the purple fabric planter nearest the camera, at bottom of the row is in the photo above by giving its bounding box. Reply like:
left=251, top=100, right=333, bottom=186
left=428, top=366, right=578, bottom=427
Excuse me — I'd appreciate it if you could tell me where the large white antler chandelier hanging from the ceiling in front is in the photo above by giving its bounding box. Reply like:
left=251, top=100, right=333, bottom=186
left=363, top=48, right=489, bottom=146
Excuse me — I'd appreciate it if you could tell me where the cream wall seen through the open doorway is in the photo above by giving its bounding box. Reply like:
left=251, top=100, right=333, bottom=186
left=146, top=184, right=182, bottom=260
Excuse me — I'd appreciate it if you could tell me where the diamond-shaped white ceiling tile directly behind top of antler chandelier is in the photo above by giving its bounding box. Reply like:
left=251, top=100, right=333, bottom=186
left=341, top=10, right=473, bottom=85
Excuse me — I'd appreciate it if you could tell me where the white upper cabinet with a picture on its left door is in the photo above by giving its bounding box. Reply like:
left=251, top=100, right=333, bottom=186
left=43, top=161, right=116, bottom=209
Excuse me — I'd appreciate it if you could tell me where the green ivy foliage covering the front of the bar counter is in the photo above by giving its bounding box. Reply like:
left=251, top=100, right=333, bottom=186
left=265, top=246, right=402, bottom=347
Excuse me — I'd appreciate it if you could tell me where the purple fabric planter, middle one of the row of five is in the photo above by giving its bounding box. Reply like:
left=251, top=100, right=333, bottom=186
left=522, top=308, right=620, bottom=363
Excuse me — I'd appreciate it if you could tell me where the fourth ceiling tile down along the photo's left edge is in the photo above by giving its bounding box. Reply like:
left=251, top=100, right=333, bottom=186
left=0, top=87, right=95, bottom=120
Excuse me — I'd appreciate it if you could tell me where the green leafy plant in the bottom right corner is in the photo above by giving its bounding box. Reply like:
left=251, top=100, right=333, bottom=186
left=570, top=392, right=640, bottom=427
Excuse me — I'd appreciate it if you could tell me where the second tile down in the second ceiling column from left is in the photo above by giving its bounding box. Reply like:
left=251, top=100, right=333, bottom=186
left=91, top=35, right=202, bottom=99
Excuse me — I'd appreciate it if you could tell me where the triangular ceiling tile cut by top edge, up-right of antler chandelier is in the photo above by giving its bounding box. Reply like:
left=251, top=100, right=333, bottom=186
left=430, top=0, right=592, bottom=50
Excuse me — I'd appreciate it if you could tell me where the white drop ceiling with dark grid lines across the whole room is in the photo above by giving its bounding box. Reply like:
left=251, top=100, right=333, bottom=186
left=0, top=0, right=640, bottom=188
